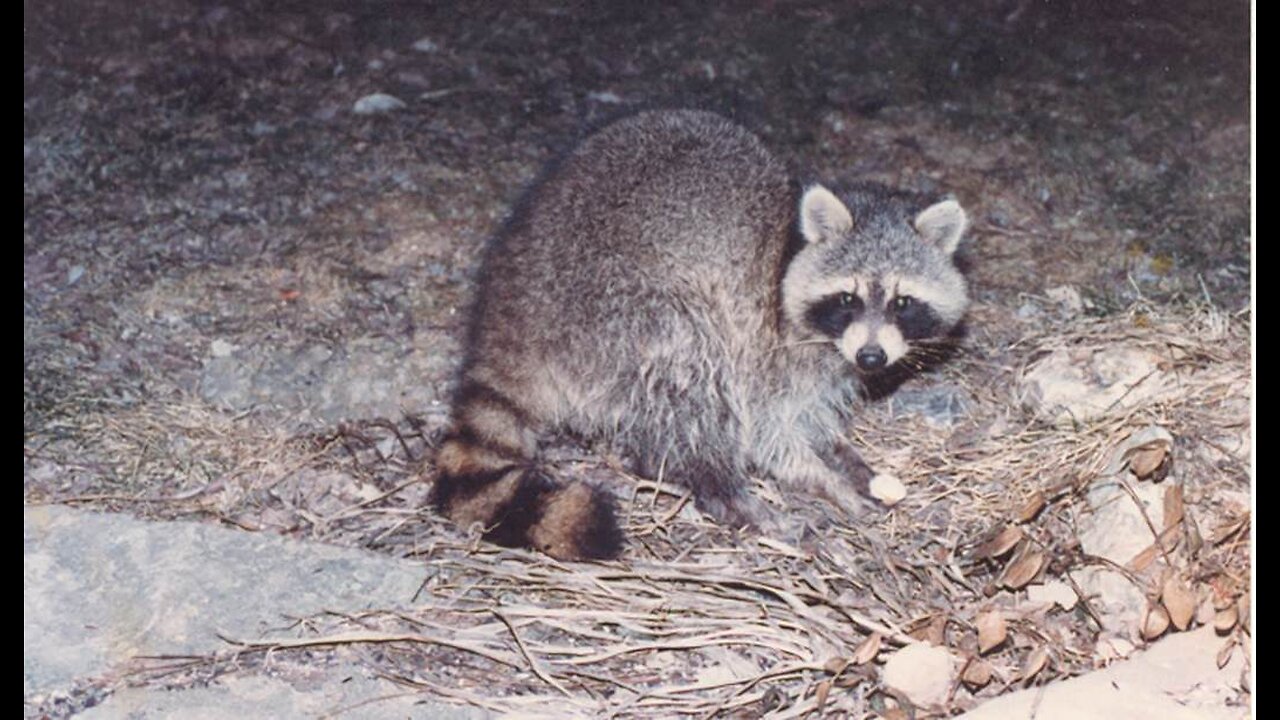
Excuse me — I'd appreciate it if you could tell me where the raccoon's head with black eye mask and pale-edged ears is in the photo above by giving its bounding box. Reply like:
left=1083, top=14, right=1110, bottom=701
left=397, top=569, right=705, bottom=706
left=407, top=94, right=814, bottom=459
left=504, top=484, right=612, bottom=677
left=782, top=186, right=969, bottom=373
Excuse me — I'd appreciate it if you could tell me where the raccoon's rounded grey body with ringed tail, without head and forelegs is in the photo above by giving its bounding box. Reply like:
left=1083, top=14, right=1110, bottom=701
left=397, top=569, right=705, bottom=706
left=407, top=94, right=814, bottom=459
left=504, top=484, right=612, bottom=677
left=435, top=111, right=799, bottom=559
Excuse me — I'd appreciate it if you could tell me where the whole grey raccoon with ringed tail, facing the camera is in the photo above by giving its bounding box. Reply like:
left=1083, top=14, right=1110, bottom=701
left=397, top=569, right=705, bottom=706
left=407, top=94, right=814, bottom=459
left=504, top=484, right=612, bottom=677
left=433, top=110, right=968, bottom=560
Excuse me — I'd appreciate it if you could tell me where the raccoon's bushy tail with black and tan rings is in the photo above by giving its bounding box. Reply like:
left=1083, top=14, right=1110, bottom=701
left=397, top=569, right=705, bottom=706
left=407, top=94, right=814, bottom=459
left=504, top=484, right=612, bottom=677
left=431, top=379, right=622, bottom=560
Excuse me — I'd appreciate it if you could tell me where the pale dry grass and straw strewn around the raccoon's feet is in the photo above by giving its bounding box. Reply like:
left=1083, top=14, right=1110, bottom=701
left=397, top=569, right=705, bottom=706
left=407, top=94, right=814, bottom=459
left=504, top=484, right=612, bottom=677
left=26, top=298, right=1251, bottom=717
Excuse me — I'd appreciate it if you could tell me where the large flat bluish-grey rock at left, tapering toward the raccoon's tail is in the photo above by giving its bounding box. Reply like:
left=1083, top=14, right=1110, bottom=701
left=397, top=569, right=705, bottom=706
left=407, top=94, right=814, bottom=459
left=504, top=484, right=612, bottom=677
left=22, top=506, right=422, bottom=696
